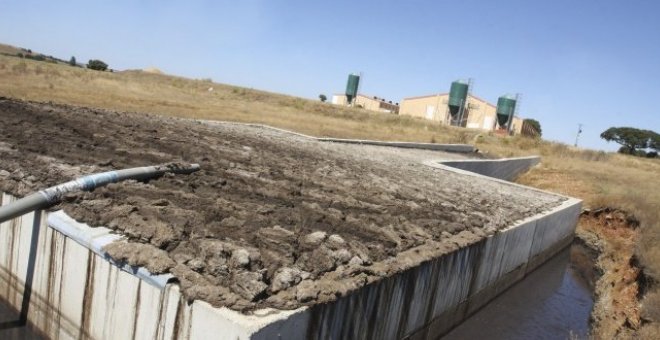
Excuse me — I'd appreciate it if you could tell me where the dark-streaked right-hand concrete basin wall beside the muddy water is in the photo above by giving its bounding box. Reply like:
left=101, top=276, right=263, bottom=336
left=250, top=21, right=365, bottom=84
left=294, top=199, right=581, bottom=339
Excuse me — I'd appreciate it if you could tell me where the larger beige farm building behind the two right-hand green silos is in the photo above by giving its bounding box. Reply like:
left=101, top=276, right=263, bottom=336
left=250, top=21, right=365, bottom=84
left=399, top=93, right=523, bottom=134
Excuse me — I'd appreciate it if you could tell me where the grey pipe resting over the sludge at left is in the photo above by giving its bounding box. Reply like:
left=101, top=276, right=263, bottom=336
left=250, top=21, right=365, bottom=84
left=0, top=163, right=200, bottom=223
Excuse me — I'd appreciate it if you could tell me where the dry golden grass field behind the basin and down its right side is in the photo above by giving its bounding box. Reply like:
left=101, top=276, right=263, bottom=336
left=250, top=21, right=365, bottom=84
left=0, top=51, right=660, bottom=336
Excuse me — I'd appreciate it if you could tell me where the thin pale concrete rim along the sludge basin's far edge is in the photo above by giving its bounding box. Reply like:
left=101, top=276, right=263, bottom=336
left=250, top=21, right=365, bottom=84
left=195, top=119, right=476, bottom=153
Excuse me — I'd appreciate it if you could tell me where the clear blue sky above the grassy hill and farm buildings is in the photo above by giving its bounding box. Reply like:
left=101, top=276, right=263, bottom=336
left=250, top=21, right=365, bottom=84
left=0, top=0, right=660, bottom=151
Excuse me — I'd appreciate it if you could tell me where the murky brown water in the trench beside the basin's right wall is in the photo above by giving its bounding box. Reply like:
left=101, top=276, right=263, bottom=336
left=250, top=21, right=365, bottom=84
left=443, top=245, right=594, bottom=340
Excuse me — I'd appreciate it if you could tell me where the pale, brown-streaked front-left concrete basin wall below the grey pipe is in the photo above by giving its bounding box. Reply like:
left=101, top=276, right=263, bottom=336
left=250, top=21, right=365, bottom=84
left=0, top=194, right=305, bottom=339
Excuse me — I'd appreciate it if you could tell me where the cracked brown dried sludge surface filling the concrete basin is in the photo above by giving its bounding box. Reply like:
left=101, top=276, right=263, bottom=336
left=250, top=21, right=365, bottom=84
left=0, top=98, right=562, bottom=312
